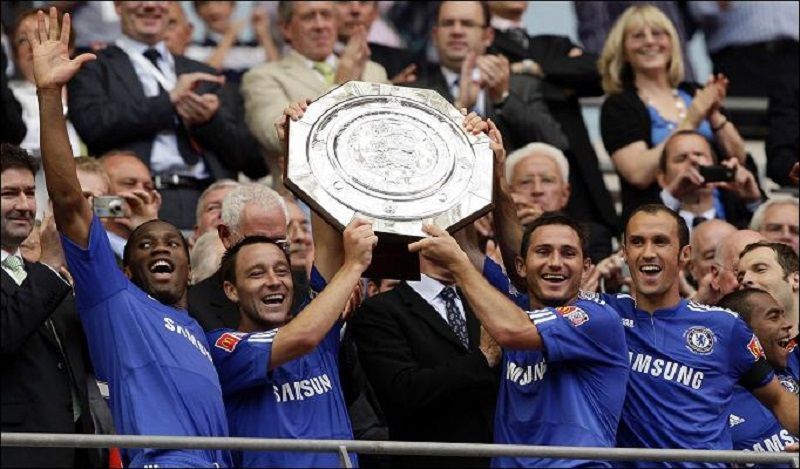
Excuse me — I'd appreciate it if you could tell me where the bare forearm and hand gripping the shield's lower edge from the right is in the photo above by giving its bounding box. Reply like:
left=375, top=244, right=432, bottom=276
left=408, top=225, right=542, bottom=350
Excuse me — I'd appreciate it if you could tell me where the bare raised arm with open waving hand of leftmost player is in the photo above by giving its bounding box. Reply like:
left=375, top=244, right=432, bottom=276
left=30, top=8, right=95, bottom=247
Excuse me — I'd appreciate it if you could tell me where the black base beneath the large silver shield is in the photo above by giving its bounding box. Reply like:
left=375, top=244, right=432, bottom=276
left=363, top=233, right=420, bottom=280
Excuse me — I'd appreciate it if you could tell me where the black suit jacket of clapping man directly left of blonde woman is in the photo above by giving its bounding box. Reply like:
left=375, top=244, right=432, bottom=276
left=492, top=30, right=619, bottom=233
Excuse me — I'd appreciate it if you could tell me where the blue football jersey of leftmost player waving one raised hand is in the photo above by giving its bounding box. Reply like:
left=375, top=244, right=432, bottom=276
left=61, top=217, right=231, bottom=467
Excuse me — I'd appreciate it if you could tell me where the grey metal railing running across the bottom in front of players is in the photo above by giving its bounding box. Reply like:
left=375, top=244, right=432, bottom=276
left=0, top=433, right=800, bottom=467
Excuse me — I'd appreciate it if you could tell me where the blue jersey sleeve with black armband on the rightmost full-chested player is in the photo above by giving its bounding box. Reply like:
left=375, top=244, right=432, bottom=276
left=730, top=318, right=775, bottom=390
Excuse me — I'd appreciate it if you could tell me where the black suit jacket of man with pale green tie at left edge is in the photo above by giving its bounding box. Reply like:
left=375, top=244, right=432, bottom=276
left=0, top=262, right=110, bottom=467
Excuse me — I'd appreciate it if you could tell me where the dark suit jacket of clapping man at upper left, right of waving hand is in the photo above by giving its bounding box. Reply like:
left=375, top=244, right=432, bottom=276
left=67, top=45, right=249, bottom=179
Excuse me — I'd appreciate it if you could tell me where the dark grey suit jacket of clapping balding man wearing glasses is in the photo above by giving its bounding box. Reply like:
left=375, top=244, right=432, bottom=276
left=408, top=64, right=568, bottom=152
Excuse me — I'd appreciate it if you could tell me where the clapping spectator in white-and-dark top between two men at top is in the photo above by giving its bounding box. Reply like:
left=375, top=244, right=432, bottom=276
left=186, top=1, right=280, bottom=83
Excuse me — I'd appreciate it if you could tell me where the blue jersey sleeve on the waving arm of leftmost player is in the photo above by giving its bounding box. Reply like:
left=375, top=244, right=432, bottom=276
left=61, top=216, right=128, bottom=309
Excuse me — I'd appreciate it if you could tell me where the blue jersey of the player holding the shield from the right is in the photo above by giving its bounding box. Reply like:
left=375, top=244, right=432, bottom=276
left=492, top=286, right=628, bottom=467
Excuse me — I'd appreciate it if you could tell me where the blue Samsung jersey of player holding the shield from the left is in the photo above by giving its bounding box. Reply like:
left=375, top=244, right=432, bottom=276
left=208, top=269, right=357, bottom=467
